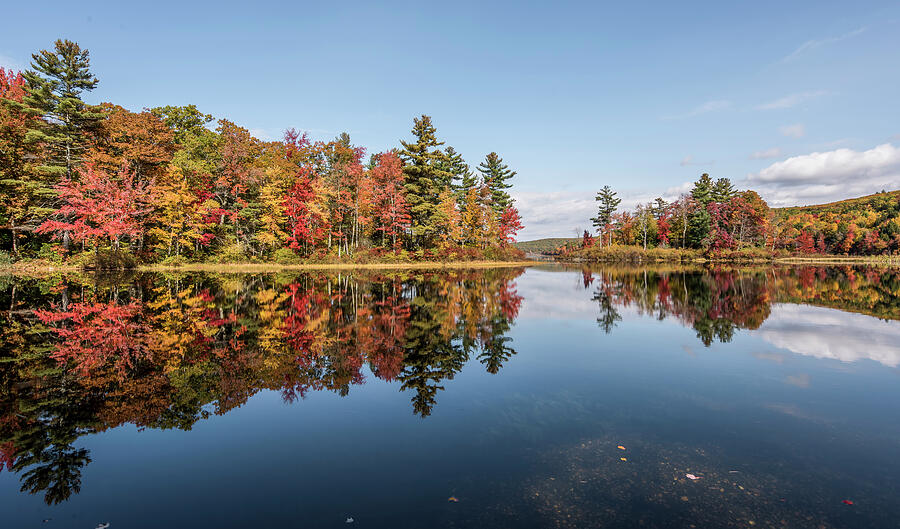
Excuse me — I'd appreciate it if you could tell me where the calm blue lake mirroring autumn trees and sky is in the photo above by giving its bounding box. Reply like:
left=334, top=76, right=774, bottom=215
left=0, top=265, right=900, bottom=529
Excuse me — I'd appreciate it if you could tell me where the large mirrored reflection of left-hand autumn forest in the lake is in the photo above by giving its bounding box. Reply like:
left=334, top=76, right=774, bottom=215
left=0, top=268, right=523, bottom=504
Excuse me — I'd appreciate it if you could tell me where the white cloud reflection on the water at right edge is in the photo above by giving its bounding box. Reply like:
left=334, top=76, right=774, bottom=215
left=753, top=304, right=900, bottom=367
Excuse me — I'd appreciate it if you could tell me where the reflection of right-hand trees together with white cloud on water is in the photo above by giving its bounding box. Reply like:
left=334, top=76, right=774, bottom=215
left=581, top=266, right=900, bottom=348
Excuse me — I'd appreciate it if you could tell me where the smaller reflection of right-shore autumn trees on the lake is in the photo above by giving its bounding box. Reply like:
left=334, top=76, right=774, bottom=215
left=581, top=266, right=900, bottom=346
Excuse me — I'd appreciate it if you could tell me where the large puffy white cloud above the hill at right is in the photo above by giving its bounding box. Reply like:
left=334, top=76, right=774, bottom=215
left=741, top=143, right=900, bottom=206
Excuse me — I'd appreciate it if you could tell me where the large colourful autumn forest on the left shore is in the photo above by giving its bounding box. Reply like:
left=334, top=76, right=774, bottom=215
left=0, top=40, right=522, bottom=268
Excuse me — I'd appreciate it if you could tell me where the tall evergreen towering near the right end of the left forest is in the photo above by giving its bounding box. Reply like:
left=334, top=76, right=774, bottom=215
left=400, top=114, right=452, bottom=246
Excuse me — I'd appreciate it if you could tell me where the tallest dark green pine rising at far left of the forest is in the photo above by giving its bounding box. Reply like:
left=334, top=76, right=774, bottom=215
left=22, top=40, right=103, bottom=178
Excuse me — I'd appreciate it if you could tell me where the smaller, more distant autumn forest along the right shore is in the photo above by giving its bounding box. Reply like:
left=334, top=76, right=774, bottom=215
left=554, top=173, right=900, bottom=258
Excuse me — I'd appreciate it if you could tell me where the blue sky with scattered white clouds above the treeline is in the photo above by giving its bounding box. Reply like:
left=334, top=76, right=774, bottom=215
left=0, top=1, right=900, bottom=239
